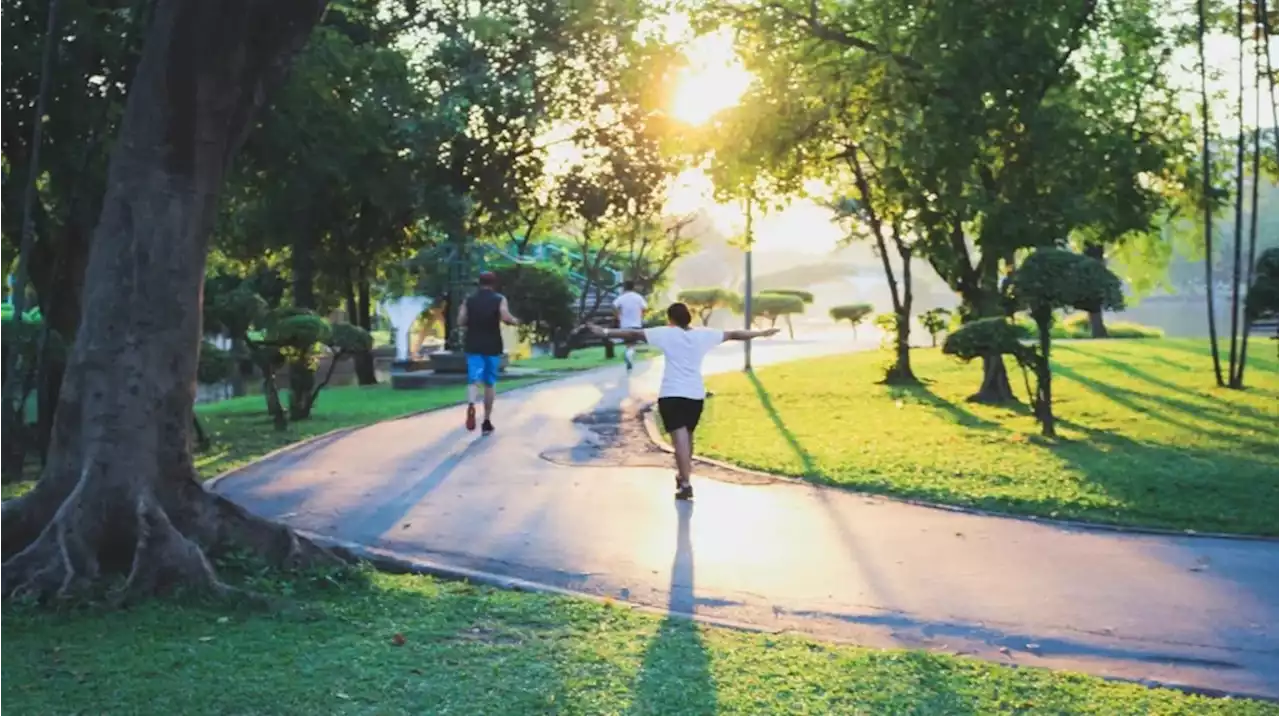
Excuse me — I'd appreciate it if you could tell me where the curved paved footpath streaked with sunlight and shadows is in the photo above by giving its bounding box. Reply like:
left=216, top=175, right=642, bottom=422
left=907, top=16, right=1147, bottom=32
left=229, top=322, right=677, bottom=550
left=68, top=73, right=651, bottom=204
left=212, top=332, right=1280, bottom=698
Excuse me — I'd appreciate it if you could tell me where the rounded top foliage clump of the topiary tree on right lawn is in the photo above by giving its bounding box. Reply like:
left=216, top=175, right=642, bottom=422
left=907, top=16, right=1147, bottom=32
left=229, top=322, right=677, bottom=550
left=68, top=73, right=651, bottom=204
left=1007, top=248, right=1124, bottom=320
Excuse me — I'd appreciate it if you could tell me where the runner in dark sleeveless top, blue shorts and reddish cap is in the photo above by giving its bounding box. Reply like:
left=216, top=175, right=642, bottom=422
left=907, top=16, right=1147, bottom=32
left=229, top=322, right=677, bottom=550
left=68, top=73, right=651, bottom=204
left=458, top=272, right=520, bottom=435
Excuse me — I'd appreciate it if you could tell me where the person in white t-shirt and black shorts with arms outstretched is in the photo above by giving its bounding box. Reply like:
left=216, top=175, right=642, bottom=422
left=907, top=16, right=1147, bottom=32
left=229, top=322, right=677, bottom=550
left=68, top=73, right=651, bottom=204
left=590, top=304, right=778, bottom=500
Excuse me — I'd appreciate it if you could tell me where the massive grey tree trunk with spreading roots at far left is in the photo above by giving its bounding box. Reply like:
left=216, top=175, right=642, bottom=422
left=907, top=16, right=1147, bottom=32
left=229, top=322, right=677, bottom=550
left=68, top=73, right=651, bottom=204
left=0, top=0, right=335, bottom=598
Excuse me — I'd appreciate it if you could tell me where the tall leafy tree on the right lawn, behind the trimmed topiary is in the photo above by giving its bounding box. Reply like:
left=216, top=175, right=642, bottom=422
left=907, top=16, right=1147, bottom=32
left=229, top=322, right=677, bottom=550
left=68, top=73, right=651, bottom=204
left=722, top=0, right=1180, bottom=401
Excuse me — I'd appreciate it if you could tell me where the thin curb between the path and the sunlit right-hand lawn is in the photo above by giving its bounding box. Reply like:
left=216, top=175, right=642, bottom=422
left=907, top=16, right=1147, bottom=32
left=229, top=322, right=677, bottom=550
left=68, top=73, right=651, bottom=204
left=640, top=402, right=1280, bottom=545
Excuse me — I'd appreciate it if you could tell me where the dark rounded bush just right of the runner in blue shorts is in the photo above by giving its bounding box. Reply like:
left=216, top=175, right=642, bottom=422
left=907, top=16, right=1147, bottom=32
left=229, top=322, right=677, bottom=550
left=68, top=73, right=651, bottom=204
left=495, top=265, right=577, bottom=343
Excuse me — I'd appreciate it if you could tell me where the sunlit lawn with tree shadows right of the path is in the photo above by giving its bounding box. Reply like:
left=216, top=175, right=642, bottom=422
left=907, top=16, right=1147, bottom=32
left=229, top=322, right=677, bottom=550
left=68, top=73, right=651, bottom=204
left=698, top=339, right=1280, bottom=535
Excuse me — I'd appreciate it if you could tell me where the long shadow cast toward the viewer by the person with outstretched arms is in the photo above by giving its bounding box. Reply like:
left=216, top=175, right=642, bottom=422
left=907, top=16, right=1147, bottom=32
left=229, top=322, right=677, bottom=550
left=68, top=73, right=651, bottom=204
left=628, top=501, right=717, bottom=715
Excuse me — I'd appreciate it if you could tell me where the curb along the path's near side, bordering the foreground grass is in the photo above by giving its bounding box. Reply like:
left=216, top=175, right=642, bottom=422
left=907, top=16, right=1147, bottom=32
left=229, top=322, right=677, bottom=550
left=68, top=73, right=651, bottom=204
left=304, top=529, right=1280, bottom=703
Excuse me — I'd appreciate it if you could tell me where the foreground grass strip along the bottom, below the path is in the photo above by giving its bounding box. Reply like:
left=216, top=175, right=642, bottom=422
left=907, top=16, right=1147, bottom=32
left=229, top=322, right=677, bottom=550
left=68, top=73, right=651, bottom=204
left=0, top=575, right=1280, bottom=716
